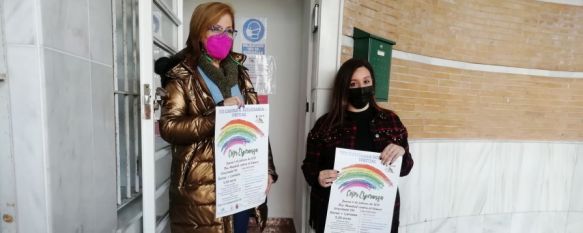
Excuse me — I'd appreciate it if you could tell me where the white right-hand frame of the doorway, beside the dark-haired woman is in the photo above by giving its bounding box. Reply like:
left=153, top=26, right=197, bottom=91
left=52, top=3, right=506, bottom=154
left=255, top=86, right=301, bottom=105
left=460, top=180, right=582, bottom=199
left=295, top=0, right=344, bottom=233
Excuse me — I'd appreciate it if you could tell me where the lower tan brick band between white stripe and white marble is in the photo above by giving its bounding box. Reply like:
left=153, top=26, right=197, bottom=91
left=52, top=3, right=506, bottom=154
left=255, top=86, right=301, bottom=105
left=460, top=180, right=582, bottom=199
left=384, top=59, right=583, bottom=141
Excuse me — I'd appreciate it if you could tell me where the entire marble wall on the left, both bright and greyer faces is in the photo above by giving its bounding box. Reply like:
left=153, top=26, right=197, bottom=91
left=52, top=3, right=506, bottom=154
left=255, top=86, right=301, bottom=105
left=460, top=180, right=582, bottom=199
left=3, top=0, right=116, bottom=232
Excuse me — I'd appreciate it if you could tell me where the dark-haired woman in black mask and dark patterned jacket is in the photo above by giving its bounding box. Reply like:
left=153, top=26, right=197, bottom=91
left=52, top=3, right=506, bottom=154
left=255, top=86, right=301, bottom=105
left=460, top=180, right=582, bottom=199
left=302, top=59, right=413, bottom=233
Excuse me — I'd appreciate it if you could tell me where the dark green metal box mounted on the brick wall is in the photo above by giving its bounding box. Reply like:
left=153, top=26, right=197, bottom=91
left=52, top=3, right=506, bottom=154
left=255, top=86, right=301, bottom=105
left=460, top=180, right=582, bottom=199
left=352, top=28, right=395, bottom=101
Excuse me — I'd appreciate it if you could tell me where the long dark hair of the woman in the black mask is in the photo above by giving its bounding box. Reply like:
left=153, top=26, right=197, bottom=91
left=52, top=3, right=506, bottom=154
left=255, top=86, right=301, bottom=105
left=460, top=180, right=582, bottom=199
left=322, top=58, right=380, bottom=130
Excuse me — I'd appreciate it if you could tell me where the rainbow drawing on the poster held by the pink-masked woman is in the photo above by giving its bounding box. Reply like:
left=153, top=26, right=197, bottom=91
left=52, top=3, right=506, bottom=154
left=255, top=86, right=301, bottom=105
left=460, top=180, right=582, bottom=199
left=216, top=119, right=264, bottom=154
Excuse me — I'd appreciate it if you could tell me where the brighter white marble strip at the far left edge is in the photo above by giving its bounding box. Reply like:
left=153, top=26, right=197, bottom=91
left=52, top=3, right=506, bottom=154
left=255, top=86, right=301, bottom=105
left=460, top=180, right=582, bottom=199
left=3, top=0, right=49, bottom=233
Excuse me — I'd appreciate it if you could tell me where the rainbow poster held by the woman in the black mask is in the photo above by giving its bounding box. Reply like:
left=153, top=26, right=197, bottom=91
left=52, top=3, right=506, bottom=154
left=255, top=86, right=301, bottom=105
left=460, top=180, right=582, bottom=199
left=324, top=148, right=401, bottom=233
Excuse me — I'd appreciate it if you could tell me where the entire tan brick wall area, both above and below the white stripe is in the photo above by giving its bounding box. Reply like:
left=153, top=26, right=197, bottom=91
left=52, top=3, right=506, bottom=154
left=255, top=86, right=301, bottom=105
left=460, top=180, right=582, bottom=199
left=341, top=0, right=583, bottom=141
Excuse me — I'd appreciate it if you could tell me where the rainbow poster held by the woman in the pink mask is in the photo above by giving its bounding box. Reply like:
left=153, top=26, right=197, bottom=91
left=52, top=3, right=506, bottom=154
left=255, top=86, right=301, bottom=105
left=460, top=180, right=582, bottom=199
left=215, top=104, right=269, bottom=218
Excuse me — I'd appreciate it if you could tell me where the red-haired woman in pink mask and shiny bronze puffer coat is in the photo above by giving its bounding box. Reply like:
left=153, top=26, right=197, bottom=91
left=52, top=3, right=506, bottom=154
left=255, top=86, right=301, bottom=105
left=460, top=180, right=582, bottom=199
left=156, top=2, right=277, bottom=233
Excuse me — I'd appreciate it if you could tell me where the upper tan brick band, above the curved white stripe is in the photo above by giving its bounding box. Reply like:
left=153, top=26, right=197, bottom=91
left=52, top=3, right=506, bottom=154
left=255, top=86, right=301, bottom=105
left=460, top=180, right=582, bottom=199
left=343, top=0, right=583, bottom=71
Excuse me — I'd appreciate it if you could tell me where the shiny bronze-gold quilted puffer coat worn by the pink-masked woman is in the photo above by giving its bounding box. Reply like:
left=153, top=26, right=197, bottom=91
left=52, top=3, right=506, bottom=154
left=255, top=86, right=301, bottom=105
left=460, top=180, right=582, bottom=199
left=160, top=53, right=277, bottom=233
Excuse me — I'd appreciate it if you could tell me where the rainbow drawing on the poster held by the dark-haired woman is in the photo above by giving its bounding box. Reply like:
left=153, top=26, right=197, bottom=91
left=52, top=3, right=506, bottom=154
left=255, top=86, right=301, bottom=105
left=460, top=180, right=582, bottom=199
left=336, top=164, right=393, bottom=192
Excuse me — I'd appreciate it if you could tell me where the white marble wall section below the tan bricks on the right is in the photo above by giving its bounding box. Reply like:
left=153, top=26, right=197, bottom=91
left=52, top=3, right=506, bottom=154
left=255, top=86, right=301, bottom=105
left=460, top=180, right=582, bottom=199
left=400, top=140, right=583, bottom=233
